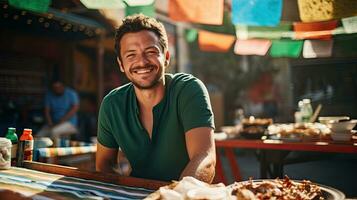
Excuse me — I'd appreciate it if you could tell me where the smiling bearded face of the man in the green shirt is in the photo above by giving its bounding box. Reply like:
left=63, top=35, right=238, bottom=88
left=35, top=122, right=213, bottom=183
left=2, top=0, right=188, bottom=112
left=118, top=30, right=169, bottom=89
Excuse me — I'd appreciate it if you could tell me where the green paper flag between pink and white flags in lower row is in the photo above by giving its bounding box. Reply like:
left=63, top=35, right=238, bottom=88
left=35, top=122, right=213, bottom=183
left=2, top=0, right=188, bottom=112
left=270, top=40, right=303, bottom=58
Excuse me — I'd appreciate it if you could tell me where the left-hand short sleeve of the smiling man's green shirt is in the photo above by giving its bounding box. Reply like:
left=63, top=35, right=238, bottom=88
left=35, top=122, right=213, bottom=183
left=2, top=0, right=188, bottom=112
left=97, top=99, right=119, bottom=148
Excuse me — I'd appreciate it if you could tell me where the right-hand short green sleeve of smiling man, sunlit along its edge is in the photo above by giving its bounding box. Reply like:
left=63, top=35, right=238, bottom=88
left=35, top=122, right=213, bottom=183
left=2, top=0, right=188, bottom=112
left=178, top=78, right=214, bottom=133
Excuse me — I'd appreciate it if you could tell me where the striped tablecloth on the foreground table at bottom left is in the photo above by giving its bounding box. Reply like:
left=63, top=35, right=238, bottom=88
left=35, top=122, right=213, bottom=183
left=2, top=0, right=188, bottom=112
left=0, top=167, right=153, bottom=199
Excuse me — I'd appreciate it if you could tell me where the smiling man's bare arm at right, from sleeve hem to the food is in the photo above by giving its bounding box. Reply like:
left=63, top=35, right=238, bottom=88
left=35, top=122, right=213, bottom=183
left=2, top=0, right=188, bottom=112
left=180, top=127, right=216, bottom=183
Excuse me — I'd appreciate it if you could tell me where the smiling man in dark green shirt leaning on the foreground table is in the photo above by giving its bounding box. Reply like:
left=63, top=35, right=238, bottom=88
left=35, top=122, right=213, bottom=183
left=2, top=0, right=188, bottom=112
left=96, top=15, right=216, bottom=182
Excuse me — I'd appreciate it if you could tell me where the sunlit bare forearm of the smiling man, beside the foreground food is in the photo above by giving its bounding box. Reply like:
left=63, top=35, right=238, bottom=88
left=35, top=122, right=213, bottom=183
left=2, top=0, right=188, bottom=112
left=180, top=154, right=216, bottom=183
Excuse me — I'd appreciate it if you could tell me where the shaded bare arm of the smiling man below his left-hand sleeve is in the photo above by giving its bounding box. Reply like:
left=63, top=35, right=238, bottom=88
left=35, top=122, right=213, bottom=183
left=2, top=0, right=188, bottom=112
left=95, top=142, right=118, bottom=173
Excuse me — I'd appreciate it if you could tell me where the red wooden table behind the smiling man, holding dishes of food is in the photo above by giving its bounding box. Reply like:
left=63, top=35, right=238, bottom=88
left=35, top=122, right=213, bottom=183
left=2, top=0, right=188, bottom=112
left=215, top=138, right=357, bottom=184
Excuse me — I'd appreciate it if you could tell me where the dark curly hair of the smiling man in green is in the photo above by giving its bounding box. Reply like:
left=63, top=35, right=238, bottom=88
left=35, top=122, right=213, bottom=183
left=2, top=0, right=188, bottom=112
left=114, top=14, right=168, bottom=61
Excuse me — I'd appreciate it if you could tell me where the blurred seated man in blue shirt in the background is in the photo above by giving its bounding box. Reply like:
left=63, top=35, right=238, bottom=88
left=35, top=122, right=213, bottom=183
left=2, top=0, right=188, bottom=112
left=36, top=80, right=79, bottom=138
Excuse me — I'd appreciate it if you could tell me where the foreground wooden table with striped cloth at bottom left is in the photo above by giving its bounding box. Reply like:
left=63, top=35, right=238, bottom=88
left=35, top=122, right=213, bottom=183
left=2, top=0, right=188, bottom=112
left=0, top=162, right=168, bottom=200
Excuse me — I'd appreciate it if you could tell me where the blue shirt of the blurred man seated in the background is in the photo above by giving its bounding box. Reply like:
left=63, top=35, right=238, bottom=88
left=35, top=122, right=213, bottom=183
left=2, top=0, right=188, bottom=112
left=45, top=87, right=79, bottom=126
